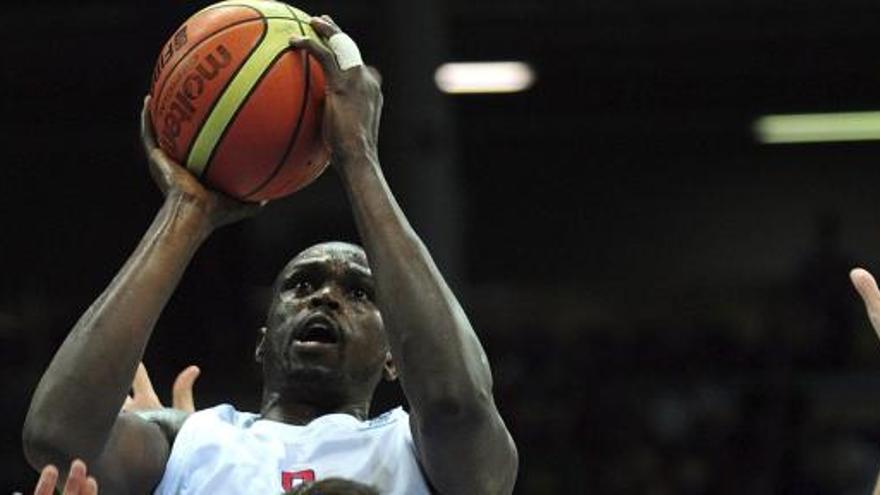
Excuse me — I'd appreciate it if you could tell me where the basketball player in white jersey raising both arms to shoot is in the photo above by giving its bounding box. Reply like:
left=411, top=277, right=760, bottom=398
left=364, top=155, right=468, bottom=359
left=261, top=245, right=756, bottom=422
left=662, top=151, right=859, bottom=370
left=24, top=13, right=518, bottom=494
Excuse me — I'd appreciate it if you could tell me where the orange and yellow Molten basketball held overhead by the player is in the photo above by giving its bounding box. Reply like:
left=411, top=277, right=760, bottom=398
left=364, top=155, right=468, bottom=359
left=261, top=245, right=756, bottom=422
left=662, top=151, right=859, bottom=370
left=149, top=0, right=330, bottom=201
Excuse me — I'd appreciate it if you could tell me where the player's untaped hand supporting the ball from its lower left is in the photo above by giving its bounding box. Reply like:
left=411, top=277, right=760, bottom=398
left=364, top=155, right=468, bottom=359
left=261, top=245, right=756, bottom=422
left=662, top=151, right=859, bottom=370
left=141, top=96, right=262, bottom=228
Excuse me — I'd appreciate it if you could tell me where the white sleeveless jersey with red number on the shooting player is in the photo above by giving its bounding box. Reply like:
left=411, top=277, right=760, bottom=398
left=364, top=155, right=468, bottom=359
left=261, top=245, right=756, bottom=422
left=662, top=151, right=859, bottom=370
left=155, top=404, right=430, bottom=495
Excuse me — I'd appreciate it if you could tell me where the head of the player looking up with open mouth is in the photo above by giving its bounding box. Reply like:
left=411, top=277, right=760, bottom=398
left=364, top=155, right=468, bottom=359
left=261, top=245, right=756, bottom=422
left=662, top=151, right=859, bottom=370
left=257, top=242, right=395, bottom=410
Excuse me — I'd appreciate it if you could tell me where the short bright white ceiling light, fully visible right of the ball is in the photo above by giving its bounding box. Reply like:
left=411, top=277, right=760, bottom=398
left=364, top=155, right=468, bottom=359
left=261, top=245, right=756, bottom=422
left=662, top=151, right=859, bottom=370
left=434, top=62, right=535, bottom=94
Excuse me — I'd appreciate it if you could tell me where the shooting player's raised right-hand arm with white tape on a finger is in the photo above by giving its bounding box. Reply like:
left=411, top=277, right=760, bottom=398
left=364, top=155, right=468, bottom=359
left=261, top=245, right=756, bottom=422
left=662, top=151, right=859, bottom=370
left=292, top=17, right=517, bottom=493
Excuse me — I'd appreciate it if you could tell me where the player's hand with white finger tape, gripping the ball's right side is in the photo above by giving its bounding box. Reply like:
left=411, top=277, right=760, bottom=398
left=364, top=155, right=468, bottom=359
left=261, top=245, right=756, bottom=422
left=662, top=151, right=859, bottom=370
left=290, top=15, right=382, bottom=167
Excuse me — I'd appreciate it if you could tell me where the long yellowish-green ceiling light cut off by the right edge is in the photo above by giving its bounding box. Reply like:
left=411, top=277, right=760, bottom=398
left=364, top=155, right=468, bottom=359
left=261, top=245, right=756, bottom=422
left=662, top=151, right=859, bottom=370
left=753, top=112, right=880, bottom=144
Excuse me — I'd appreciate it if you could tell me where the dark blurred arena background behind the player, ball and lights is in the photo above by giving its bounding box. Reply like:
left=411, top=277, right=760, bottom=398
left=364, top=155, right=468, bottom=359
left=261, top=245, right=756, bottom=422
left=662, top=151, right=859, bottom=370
left=0, top=0, right=880, bottom=494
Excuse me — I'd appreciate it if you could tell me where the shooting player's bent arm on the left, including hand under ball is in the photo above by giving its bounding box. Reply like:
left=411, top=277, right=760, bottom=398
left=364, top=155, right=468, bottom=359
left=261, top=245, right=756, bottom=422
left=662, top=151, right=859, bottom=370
left=23, top=101, right=257, bottom=493
